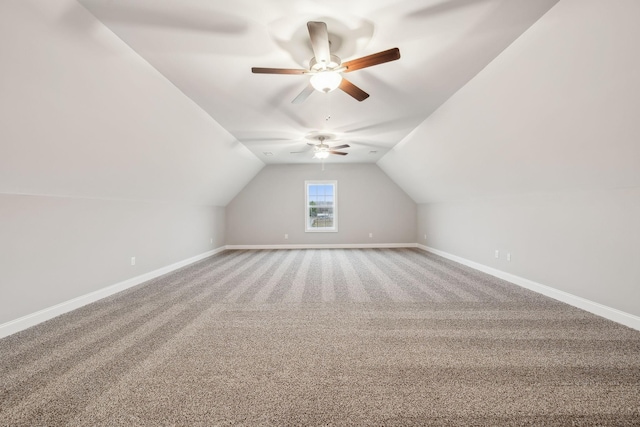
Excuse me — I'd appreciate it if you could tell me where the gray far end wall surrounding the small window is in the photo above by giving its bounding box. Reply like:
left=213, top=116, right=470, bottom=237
left=227, top=162, right=416, bottom=245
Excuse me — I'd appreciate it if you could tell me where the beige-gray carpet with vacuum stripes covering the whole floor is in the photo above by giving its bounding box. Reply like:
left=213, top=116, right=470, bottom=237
left=0, top=249, right=640, bottom=426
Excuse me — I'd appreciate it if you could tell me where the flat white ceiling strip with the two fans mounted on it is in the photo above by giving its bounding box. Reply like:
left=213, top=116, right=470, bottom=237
left=79, top=0, right=558, bottom=163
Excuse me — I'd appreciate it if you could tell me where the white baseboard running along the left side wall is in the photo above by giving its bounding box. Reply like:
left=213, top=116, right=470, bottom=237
left=0, top=246, right=226, bottom=338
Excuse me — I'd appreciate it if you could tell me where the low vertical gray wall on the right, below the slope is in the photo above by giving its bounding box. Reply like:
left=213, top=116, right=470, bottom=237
left=418, top=188, right=640, bottom=316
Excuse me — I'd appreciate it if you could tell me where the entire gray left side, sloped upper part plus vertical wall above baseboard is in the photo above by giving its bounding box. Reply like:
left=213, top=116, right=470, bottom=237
left=0, top=0, right=263, bottom=324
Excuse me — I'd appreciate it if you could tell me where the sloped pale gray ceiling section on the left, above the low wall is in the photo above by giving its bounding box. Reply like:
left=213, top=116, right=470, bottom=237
left=0, top=0, right=264, bottom=206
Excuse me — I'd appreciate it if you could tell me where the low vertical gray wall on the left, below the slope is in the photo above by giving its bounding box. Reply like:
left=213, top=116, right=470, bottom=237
left=0, top=195, right=225, bottom=324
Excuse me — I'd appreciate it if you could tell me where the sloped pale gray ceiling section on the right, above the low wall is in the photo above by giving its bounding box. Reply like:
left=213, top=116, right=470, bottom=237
left=378, top=0, right=640, bottom=204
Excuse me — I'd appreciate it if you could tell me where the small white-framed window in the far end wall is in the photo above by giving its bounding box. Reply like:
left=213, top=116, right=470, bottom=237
left=305, top=181, right=338, bottom=232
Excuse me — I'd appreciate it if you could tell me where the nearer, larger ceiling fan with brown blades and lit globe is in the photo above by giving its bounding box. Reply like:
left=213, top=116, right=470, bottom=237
left=251, top=21, right=400, bottom=104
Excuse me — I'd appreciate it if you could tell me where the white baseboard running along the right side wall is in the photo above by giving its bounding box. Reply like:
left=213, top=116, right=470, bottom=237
left=416, top=244, right=640, bottom=331
